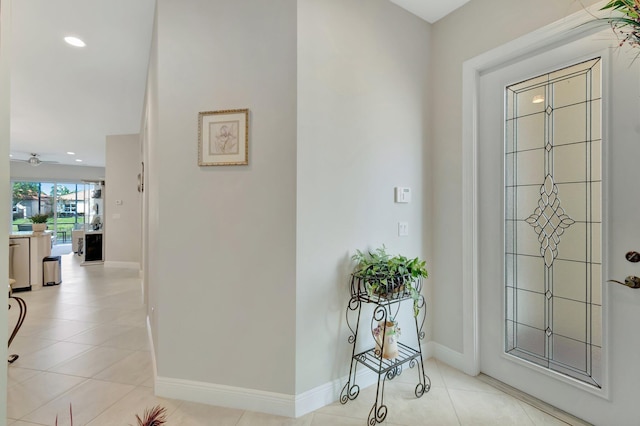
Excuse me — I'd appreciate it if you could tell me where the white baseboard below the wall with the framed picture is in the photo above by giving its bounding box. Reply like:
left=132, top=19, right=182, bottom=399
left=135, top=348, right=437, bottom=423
left=155, top=376, right=295, bottom=417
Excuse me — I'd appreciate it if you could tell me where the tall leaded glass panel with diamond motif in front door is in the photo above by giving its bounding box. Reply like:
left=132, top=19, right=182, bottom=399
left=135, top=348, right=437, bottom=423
left=505, top=58, right=602, bottom=387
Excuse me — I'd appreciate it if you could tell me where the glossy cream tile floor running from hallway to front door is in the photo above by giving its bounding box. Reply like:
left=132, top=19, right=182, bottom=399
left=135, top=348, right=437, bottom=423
left=7, top=255, right=584, bottom=426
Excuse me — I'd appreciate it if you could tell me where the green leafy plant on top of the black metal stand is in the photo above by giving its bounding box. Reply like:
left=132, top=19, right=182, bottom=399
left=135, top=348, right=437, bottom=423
left=352, top=245, right=429, bottom=316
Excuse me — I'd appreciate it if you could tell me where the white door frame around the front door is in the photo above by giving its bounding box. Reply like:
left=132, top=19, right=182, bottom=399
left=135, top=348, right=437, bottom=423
left=457, top=0, right=609, bottom=376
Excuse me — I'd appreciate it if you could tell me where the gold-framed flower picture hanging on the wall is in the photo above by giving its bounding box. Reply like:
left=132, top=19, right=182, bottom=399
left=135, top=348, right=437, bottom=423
left=198, top=109, right=249, bottom=166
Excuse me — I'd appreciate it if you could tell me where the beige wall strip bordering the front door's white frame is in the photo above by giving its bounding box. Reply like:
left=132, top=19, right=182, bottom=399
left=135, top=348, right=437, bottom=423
left=427, top=0, right=596, bottom=352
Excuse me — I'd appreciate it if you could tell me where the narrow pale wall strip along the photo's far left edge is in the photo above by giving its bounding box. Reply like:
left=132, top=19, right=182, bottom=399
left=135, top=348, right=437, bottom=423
left=0, top=0, right=11, bottom=422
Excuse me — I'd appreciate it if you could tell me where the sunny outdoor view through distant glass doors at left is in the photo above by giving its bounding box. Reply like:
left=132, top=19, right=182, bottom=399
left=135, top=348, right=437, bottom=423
left=11, top=181, right=87, bottom=244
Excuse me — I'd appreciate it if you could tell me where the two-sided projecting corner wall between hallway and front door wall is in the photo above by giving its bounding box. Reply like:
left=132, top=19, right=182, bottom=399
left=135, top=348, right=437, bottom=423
left=145, top=0, right=431, bottom=415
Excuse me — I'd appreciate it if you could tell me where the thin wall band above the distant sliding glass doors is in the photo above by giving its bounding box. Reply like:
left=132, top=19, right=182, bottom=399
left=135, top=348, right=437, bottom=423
left=10, top=161, right=105, bottom=183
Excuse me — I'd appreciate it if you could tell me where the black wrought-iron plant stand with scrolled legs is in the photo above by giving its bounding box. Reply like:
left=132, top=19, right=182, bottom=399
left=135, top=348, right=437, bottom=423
left=340, top=275, right=431, bottom=426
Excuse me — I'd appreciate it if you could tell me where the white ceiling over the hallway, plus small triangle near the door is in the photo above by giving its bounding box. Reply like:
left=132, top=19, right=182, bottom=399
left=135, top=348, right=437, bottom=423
left=11, top=0, right=469, bottom=167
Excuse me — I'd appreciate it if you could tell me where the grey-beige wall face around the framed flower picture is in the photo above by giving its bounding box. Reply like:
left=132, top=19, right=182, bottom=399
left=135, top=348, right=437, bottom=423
left=149, top=0, right=296, bottom=395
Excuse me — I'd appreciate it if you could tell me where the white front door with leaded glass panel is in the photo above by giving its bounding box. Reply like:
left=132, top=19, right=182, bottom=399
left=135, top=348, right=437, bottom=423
left=478, top=30, right=640, bottom=425
